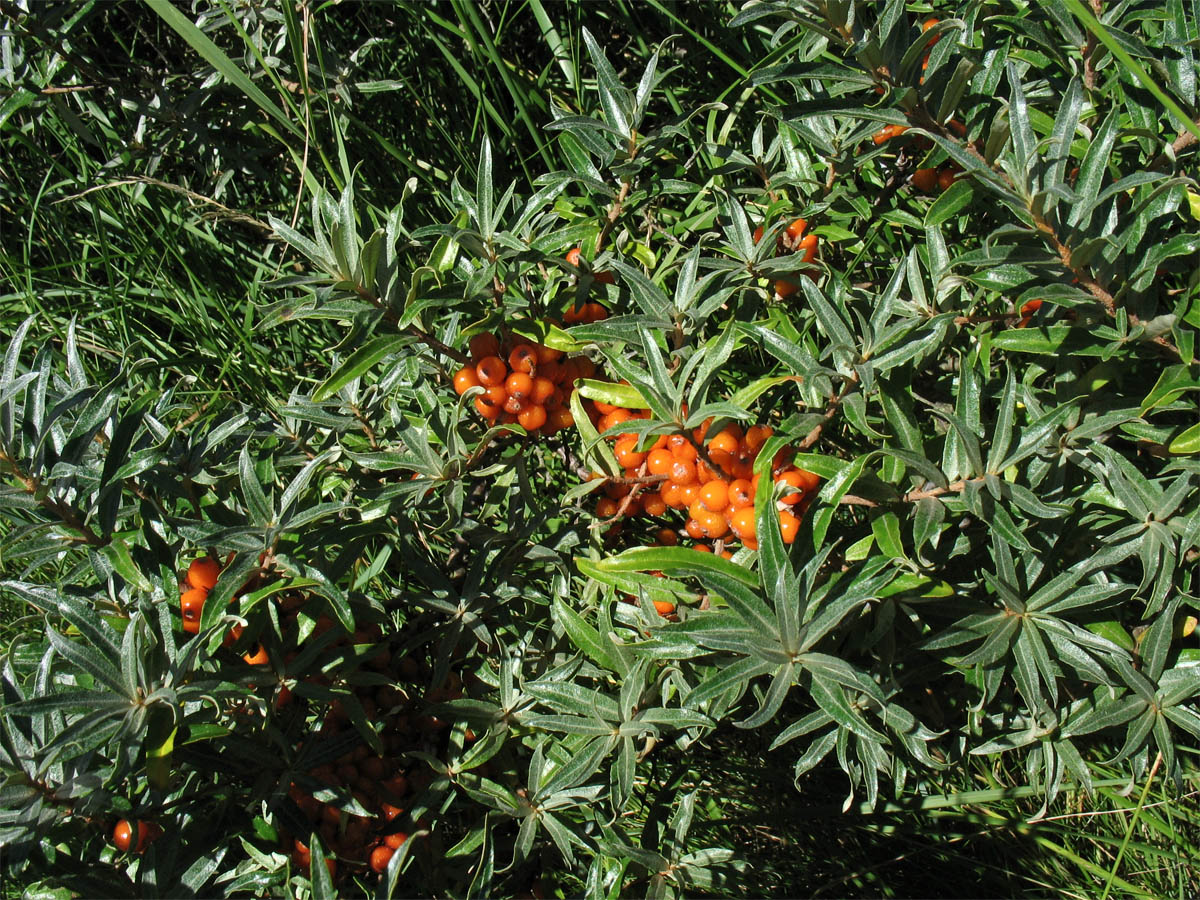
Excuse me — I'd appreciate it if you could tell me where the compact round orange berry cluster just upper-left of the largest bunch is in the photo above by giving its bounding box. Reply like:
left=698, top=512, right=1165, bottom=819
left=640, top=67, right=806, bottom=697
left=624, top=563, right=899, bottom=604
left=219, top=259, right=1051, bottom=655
left=454, top=328, right=608, bottom=434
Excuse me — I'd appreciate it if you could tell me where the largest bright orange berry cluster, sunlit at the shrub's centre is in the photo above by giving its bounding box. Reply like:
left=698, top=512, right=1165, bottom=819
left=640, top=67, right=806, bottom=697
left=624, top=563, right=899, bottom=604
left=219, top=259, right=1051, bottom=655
left=596, top=420, right=820, bottom=550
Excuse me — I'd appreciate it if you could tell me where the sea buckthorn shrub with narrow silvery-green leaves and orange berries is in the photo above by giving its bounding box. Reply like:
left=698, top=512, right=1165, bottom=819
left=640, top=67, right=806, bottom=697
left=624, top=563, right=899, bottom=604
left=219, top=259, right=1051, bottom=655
left=0, top=2, right=1200, bottom=896
